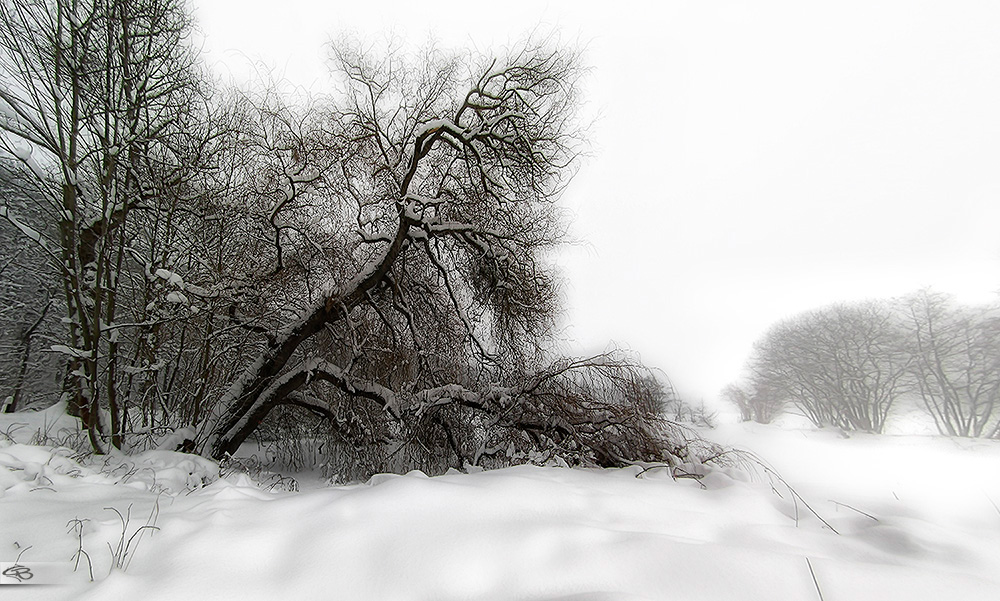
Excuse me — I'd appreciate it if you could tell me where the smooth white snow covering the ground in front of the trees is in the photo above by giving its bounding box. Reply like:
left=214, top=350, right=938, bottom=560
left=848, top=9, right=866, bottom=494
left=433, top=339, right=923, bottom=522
left=0, top=408, right=1000, bottom=601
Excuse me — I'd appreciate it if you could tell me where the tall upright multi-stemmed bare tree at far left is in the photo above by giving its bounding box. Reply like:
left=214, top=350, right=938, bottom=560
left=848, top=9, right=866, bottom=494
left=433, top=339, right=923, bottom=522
left=0, top=0, right=205, bottom=450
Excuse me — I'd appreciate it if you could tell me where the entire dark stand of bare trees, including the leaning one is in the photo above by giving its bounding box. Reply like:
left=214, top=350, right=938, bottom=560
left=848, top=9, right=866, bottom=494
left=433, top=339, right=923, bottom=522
left=0, top=0, right=720, bottom=475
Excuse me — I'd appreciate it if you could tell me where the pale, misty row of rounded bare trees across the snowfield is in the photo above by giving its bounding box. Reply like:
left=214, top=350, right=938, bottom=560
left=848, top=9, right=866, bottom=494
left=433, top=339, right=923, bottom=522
left=723, top=290, right=1000, bottom=437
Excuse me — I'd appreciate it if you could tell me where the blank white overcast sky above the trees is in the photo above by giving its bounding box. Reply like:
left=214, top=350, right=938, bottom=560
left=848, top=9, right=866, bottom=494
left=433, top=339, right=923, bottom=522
left=192, top=0, right=1000, bottom=401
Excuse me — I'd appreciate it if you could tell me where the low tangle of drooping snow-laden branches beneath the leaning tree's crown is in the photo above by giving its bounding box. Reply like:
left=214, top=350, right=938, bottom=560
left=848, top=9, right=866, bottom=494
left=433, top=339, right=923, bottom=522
left=249, top=355, right=728, bottom=481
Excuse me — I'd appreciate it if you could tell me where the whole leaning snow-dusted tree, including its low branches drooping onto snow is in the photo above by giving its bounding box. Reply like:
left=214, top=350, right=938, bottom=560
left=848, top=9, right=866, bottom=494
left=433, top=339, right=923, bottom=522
left=197, top=42, right=712, bottom=474
